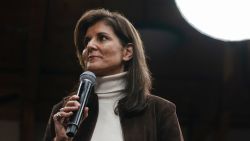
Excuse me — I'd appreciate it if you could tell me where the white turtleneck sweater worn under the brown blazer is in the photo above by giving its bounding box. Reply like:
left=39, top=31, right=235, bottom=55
left=91, top=72, right=127, bottom=141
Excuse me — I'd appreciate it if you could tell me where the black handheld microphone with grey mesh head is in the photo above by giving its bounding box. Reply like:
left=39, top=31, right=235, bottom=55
left=66, top=71, right=96, bottom=137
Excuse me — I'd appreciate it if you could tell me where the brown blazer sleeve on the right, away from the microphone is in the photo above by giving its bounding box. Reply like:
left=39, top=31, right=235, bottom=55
left=157, top=99, right=184, bottom=141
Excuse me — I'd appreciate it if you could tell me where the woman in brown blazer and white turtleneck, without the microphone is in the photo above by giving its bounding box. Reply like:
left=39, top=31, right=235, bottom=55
left=44, top=9, right=183, bottom=141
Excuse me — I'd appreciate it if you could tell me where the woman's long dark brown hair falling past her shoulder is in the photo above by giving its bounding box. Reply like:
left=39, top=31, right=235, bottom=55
left=74, top=9, right=151, bottom=113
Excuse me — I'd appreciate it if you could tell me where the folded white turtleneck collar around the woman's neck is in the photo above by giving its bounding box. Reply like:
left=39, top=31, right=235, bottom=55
left=94, top=72, right=127, bottom=94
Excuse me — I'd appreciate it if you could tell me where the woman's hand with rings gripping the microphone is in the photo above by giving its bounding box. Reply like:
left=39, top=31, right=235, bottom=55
left=53, top=95, right=88, bottom=141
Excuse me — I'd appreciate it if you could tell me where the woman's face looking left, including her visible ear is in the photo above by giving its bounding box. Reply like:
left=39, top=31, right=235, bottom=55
left=82, top=21, right=133, bottom=76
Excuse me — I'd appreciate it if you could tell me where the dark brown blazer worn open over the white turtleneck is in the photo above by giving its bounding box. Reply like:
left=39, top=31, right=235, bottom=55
left=44, top=94, right=184, bottom=141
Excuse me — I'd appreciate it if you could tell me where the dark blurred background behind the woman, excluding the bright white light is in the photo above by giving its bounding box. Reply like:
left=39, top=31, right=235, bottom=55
left=0, top=0, right=250, bottom=141
